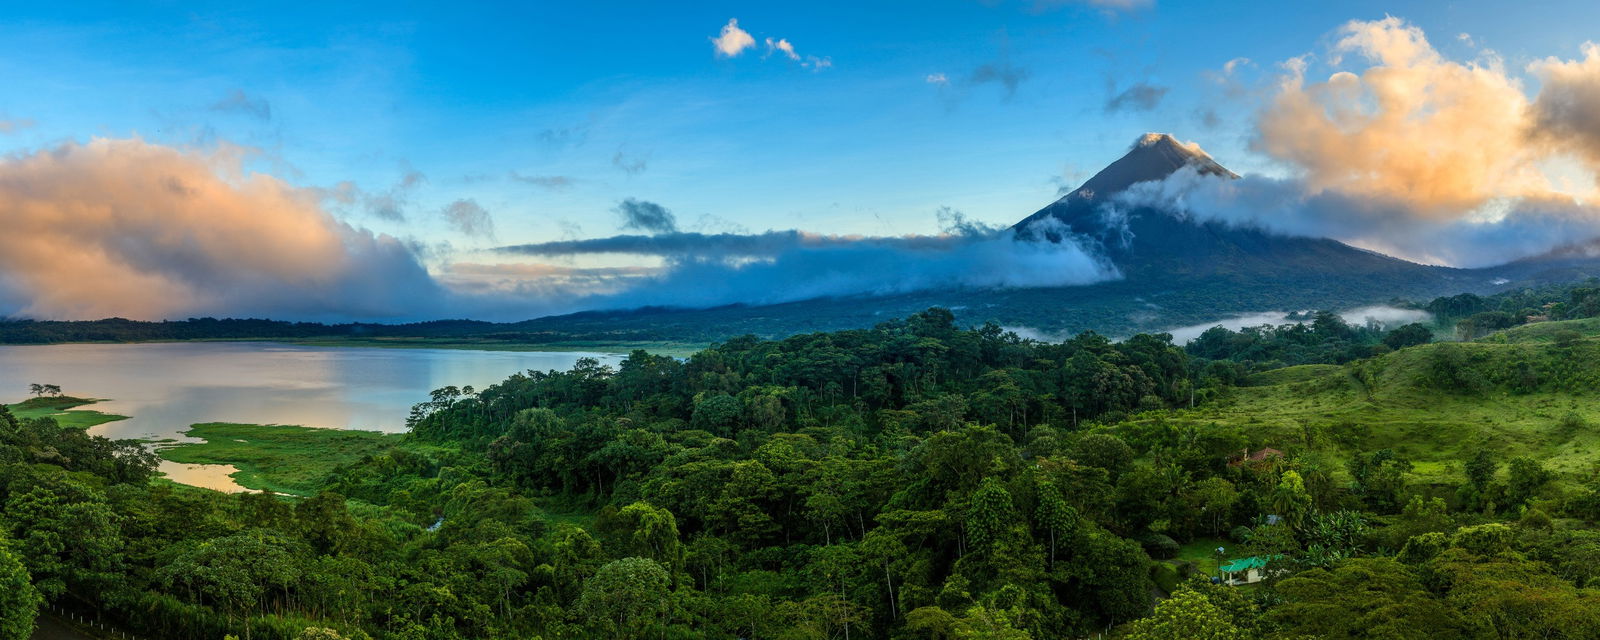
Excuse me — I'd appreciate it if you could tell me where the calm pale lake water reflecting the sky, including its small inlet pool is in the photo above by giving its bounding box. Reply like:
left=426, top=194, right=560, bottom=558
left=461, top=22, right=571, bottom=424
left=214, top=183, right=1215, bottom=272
left=0, top=342, right=621, bottom=490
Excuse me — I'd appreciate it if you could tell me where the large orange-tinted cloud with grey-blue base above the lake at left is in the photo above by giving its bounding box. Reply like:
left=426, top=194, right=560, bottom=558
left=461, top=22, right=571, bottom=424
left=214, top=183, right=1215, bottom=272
left=0, top=139, right=438, bottom=318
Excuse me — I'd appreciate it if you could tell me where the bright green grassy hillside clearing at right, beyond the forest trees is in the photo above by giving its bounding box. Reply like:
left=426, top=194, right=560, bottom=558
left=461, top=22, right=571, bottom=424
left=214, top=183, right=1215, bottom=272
left=1165, top=339, right=1600, bottom=485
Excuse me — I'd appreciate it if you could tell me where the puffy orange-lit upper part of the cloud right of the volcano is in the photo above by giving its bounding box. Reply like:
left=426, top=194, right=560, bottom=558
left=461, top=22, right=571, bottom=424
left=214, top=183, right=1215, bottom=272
left=1254, top=18, right=1555, bottom=218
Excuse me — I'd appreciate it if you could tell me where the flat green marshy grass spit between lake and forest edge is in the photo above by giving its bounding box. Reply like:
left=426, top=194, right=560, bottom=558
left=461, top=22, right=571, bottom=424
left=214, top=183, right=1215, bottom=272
left=158, top=422, right=400, bottom=496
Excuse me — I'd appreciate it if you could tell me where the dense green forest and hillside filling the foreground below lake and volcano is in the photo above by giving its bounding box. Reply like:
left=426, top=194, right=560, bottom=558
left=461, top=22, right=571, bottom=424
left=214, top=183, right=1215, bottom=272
left=9, top=285, right=1600, bottom=640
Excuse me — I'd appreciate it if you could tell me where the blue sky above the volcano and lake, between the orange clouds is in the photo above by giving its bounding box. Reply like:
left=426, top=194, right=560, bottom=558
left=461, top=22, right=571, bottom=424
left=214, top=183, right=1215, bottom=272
left=0, top=0, right=1600, bottom=315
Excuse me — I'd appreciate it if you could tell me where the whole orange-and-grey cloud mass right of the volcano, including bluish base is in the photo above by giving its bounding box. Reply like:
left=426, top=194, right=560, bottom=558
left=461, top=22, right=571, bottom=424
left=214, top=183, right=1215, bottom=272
left=1122, top=18, right=1600, bottom=267
